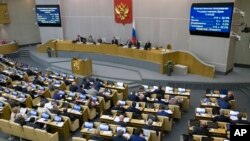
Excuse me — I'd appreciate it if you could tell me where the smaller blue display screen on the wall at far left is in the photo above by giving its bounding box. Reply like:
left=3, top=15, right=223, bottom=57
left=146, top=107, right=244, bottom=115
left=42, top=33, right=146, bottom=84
left=36, top=5, right=61, bottom=27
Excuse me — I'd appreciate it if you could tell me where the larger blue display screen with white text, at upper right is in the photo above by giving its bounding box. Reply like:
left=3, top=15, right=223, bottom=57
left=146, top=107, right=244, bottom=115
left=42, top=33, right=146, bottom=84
left=189, top=3, right=234, bottom=38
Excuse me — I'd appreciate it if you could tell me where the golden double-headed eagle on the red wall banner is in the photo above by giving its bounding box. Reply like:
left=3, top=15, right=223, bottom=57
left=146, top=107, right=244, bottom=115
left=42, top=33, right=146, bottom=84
left=115, top=3, right=129, bottom=20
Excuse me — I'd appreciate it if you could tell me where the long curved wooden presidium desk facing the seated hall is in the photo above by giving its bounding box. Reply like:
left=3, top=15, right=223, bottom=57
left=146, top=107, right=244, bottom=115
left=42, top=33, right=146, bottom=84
left=37, top=40, right=215, bottom=77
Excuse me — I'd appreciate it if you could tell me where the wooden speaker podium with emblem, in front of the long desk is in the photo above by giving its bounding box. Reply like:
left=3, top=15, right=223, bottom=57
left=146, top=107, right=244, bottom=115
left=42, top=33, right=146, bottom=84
left=71, top=58, right=92, bottom=75
